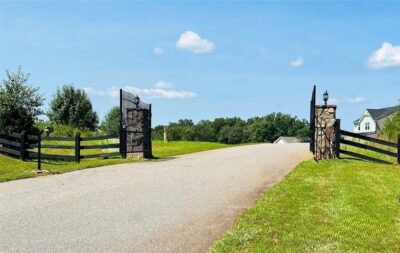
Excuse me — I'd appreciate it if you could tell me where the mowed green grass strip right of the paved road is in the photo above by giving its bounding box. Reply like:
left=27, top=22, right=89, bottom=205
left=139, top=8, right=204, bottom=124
left=210, top=159, right=400, bottom=252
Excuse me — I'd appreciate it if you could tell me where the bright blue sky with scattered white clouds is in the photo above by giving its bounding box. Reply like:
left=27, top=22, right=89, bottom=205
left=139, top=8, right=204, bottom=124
left=0, top=1, right=400, bottom=129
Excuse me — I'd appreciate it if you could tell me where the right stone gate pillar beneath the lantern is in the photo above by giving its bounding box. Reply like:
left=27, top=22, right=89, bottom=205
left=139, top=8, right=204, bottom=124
left=314, top=105, right=336, bottom=160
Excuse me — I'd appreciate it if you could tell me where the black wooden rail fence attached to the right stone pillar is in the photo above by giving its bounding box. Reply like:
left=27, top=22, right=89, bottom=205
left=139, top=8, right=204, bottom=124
left=335, top=119, right=400, bottom=164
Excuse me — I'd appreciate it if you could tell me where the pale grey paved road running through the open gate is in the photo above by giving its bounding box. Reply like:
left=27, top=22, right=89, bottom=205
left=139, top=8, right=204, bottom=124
left=0, top=144, right=310, bottom=253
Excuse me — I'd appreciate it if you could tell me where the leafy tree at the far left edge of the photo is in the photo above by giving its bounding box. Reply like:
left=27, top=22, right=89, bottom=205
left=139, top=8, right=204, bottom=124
left=0, top=67, right=44, bottom=132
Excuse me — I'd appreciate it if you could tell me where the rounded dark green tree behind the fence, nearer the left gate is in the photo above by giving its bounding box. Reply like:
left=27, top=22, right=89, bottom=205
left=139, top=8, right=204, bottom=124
left=48, top=85, right=99, bottom=131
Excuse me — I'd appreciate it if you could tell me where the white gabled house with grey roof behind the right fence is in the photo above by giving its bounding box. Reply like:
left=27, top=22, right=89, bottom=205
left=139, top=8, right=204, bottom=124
left=353, top=106, right=399, bottom=135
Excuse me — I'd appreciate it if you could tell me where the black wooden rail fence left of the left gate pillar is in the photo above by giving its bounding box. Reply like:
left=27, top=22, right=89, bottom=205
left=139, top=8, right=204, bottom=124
left=0, top=132, right=122, bottom=168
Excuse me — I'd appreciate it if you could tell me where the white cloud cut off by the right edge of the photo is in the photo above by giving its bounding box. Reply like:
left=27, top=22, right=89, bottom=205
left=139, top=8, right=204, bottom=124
left=368, top=42, right=400, bottom=69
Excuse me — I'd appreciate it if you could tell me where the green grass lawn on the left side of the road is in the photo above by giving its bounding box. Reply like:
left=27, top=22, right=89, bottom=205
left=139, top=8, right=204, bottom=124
left=0, top=141, right=229, bottom=182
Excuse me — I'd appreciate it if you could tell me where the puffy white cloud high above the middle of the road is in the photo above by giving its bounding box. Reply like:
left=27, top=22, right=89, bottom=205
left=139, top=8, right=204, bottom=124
left=176, top=31, right=215, bottom=54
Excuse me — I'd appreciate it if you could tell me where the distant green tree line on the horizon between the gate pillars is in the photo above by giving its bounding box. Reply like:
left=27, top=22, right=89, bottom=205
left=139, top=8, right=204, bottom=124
left=153, top=113, right=309, bottom=144
